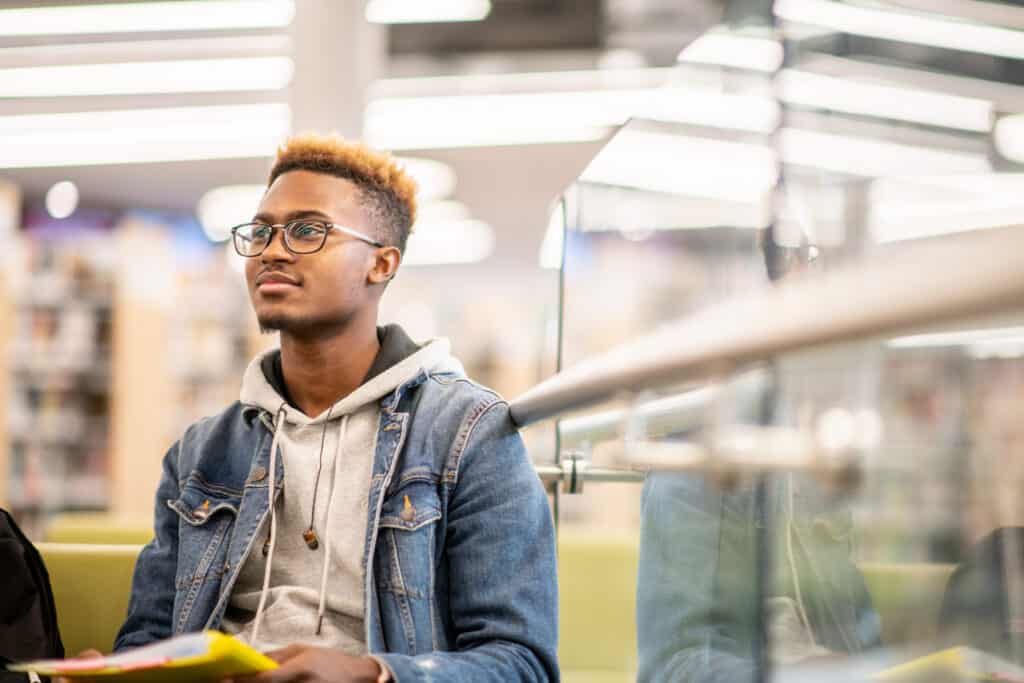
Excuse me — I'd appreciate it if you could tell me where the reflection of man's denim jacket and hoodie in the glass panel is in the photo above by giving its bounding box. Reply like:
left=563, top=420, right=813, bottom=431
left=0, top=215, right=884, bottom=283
left=637, top=473, right=880, bottom=683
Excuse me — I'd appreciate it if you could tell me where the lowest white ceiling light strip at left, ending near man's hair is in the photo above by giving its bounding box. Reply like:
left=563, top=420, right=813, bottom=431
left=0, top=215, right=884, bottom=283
left=0, top=103, right=291, bottom=168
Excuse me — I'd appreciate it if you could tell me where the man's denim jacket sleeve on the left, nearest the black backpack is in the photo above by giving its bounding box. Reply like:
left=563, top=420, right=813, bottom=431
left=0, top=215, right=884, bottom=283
left=114, top=442, right=180, bottom=650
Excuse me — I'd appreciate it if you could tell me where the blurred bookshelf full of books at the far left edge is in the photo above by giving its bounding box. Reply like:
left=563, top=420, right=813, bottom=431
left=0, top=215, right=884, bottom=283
left=6, top=238, right=114, bottom=536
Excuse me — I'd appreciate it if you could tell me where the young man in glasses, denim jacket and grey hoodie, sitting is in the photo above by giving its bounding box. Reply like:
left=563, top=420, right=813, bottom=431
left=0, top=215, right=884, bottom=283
left=115, top=136, right=558, bottom=683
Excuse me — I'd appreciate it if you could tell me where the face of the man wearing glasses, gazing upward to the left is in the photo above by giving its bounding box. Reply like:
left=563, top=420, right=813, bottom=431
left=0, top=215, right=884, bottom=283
left=246, top=171, right=385, bottom=335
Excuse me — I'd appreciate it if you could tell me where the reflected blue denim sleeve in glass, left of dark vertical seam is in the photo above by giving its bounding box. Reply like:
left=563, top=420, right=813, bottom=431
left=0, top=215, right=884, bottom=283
left=637, top=474, right=756, bottom=683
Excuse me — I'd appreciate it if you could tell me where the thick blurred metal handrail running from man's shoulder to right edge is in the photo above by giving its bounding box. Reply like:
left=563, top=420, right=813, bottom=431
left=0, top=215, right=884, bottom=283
left=511, top=226, right=1024, bottom=426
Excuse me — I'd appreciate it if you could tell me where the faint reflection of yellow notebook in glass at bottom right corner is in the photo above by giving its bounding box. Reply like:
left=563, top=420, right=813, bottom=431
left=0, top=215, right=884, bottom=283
left=874, top=647, right=1024, bottom=683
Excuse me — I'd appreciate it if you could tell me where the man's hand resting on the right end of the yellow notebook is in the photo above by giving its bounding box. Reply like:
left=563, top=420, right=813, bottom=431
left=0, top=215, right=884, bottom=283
left=221, top=645, right=381, bottom=683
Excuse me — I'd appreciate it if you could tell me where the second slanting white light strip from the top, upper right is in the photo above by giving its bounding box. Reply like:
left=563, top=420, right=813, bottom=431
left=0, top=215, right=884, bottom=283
left=777, top=69, right=992, bottom=133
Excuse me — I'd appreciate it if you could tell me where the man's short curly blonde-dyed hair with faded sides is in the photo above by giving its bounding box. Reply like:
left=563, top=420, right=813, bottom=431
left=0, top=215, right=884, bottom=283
left=267, top=133, right=417, bottom=251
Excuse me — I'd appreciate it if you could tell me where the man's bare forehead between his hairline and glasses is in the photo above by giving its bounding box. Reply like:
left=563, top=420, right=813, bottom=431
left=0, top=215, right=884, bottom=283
left=257, top=171, right=366, bottom=227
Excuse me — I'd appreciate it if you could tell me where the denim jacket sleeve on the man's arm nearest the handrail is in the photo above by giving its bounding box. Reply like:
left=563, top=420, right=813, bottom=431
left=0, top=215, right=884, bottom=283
left=375, top=401, right=558, bottom=683
